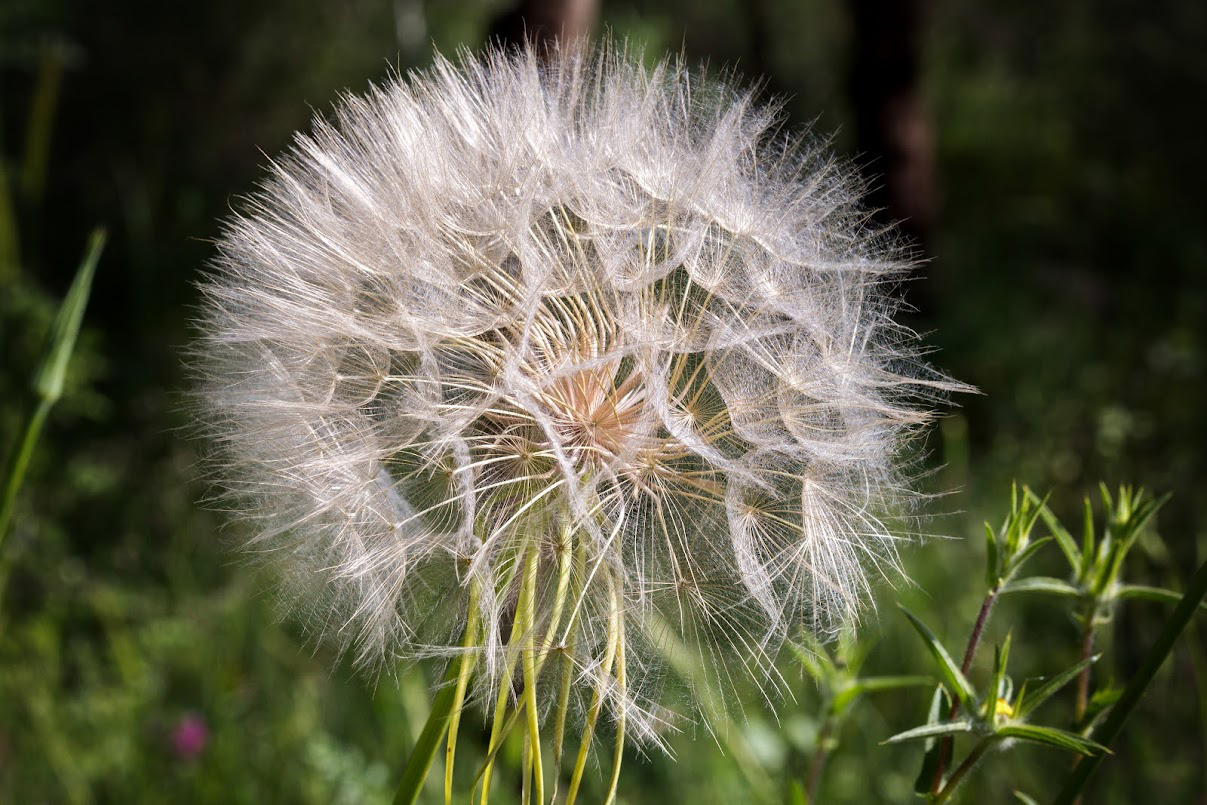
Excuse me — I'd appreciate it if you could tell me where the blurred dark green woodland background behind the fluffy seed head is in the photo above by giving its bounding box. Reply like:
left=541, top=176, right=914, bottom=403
left=0, top=0, right=1207, bottom=803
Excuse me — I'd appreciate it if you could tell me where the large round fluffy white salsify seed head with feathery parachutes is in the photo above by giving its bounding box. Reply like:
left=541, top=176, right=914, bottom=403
left=194, top=37, right=955, bottom=740
